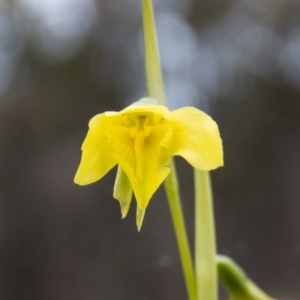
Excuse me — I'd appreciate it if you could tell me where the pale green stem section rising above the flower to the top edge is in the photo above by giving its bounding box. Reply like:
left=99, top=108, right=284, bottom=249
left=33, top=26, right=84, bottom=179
left=143, top=0, right=166, bottom=105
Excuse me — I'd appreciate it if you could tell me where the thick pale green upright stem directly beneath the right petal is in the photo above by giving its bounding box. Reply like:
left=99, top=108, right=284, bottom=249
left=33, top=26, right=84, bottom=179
left=194, top=169, right=218, bottom=300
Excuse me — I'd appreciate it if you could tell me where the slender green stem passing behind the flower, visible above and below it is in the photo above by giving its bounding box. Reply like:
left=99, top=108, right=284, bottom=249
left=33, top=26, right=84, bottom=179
left=142, top=0, right=197, bottom=300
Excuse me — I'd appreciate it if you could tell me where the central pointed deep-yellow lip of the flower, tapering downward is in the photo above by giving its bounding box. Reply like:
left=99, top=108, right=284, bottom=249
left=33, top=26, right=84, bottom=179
left=105, top=115, right=172, bottom=210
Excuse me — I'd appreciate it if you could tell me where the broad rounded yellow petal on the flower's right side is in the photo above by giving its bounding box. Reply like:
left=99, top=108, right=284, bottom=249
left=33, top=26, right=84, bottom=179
left=169, top=107, right=223, bottom=170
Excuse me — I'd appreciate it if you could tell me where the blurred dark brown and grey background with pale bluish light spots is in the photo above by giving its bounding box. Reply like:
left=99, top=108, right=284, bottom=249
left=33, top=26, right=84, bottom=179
left=0, top=0, right=300, bottom=300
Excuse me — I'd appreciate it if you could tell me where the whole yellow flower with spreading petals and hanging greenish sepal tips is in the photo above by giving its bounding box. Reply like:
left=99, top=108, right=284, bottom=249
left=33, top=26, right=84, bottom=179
left=74, top=98, right=223, bottom=229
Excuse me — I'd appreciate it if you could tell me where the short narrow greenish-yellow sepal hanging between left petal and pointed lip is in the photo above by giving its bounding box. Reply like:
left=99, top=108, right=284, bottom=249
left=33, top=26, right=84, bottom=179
left=113, top=166, right=132, bottom=219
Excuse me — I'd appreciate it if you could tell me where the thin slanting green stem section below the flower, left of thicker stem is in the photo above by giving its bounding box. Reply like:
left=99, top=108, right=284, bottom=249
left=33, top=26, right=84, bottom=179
left=164, top=160, right=197, bottom=300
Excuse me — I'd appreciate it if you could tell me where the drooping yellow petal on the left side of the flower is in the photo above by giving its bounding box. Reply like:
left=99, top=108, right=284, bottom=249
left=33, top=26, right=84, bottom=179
left=74, top=114, right=116, bottom=185
